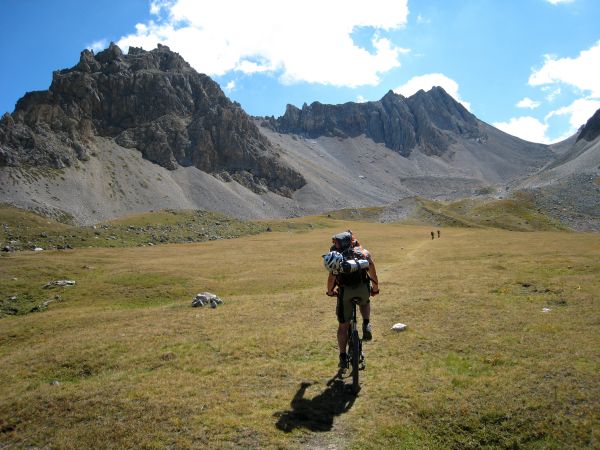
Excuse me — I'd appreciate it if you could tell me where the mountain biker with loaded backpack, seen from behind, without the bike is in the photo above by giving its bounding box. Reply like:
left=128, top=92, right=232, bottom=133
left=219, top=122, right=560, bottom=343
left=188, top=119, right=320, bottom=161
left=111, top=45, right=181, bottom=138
left=326, top=230, right=379, bottom=368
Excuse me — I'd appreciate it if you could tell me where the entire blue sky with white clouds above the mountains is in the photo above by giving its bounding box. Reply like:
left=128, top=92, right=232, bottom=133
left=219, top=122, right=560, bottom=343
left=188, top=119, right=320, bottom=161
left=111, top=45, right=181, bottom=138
left=0, top=0, right=600, bottom=142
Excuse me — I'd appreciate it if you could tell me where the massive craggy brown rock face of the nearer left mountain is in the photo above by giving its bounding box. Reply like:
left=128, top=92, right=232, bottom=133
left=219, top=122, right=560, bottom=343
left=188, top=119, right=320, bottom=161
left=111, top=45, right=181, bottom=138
left=0, top=44, right=305, bottom=195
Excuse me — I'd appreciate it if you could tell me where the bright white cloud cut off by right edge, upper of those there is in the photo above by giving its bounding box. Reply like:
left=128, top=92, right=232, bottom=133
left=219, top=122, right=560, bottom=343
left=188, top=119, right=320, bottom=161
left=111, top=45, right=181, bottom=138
left=529, top=41, right=600, bottom=97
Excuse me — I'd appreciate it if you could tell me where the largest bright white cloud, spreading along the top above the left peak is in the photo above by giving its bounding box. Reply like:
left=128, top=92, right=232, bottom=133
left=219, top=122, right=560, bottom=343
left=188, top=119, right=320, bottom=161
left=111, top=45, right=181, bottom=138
left=118, top=0, right=408, bottom=87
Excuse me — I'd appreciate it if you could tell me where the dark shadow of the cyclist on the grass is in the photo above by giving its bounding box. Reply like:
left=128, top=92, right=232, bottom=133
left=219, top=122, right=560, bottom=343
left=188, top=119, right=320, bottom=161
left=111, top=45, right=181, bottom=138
left=274, top=371, right=356, bottom=432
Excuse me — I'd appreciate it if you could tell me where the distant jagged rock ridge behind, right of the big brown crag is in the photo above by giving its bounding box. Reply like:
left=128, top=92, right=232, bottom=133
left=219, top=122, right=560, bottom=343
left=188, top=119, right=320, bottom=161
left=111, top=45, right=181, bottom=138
left=268, top=87, right=485, bottom=156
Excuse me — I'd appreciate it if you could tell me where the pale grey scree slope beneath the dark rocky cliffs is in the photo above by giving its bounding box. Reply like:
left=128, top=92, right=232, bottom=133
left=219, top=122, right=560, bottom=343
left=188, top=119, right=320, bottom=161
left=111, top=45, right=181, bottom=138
left=0, top=120, right=554, bottom=224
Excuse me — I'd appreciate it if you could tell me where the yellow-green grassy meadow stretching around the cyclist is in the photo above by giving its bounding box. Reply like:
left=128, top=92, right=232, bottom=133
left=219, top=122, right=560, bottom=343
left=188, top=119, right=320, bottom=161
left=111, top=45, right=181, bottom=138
left=0, top=221, right=600, bottom=449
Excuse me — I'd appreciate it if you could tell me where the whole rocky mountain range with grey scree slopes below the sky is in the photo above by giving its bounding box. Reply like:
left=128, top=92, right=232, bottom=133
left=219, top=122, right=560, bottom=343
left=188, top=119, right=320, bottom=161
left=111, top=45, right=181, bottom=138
left=0, top=44, right=600, bottom=230
